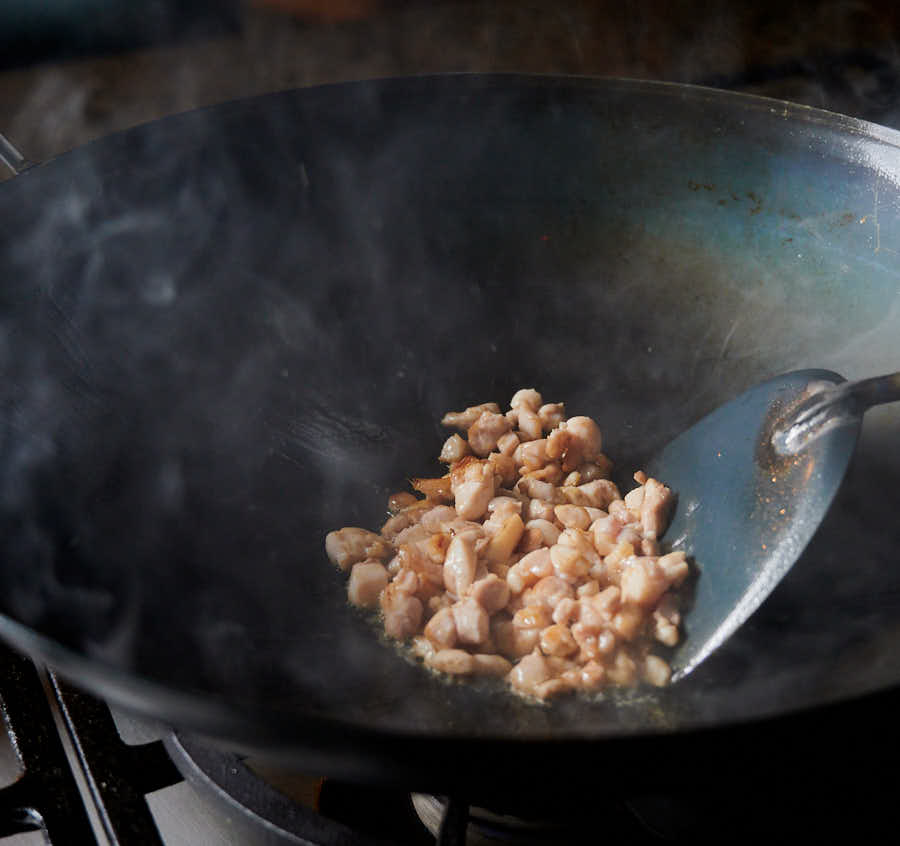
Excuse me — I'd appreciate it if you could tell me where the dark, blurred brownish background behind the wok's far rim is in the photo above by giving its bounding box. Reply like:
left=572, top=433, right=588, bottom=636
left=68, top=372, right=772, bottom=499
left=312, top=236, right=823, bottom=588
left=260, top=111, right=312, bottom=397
left=0, top=0, right=900, bottom=176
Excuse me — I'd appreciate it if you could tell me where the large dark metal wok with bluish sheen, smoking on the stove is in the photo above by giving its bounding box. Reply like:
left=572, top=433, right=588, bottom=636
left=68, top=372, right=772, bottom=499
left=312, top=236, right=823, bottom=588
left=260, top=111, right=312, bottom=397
left=0, top=76, right=900, bottom=800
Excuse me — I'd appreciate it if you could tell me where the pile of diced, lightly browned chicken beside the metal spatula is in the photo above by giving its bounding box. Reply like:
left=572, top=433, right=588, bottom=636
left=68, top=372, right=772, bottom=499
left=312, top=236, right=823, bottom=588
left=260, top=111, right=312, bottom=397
left=325, top=388, right=690, bottom=700
